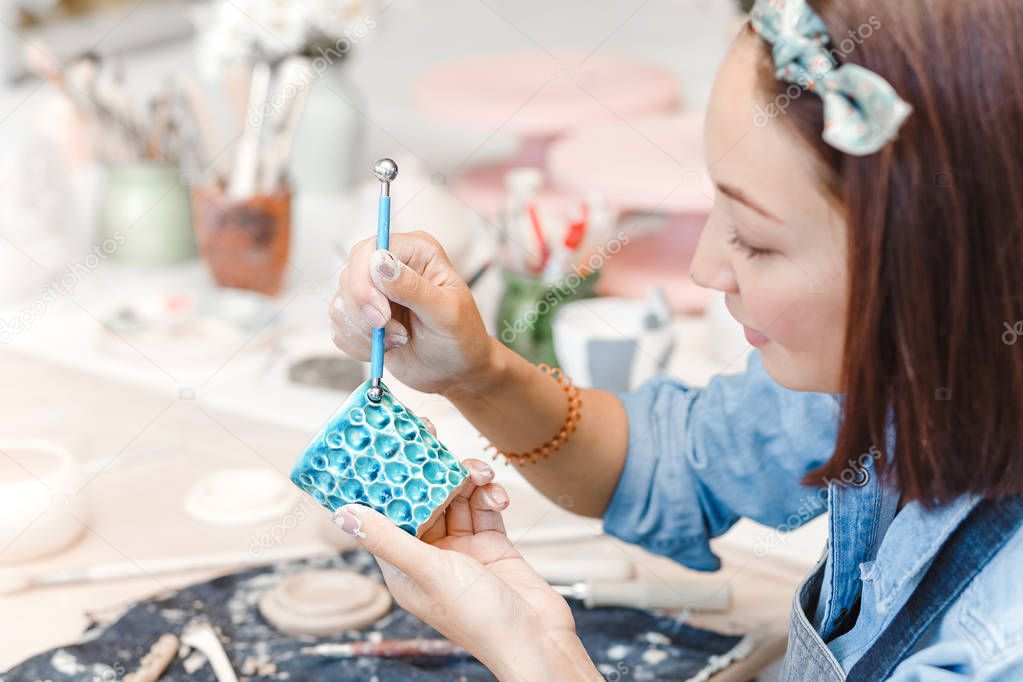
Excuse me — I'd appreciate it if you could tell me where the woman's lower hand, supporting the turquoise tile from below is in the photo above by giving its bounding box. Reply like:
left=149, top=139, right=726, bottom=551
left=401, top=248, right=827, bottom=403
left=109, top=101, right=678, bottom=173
left=335, top=459, right=603, bottom=680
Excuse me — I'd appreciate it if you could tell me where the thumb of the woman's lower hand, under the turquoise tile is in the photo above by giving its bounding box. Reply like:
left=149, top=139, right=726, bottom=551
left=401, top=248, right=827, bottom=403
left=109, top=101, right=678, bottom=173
left=333, top=504, right=437, bottom=583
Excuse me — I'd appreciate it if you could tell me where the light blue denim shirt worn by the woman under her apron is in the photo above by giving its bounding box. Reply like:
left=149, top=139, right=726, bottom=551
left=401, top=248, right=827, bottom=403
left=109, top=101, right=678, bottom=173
left=604, top=353, right=1023, bottom=682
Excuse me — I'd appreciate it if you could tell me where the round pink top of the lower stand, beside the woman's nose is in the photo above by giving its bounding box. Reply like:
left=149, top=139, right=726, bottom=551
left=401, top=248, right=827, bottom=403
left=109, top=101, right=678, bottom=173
left=547, top=113, right=714, bottom=215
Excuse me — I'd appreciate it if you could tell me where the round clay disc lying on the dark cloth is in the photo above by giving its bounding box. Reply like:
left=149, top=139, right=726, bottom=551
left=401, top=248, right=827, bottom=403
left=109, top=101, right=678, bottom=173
left=259, top=571, right=391, bottom=637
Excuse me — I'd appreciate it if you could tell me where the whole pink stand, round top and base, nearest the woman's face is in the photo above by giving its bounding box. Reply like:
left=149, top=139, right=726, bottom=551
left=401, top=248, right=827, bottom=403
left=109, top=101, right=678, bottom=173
left=547, top=113, right=714, bottom=314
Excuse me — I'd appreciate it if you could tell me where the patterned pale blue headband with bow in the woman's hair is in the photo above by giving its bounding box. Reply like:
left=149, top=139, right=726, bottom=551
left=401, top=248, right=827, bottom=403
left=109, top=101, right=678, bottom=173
left=750, top=0, right=913, bottom=156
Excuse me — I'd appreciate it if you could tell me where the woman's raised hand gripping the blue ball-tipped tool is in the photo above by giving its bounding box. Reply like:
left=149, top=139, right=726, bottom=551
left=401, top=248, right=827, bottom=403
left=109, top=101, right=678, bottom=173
left=330, top=232, right=493, bottom=394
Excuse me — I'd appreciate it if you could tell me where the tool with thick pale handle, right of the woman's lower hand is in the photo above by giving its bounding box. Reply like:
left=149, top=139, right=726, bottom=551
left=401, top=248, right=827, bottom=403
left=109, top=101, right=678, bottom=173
left=551, top=580, right=731, bottom=613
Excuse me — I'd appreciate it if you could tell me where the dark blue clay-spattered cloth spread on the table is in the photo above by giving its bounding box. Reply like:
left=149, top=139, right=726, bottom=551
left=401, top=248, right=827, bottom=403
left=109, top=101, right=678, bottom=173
left=0, top=550, right=742, bottom=682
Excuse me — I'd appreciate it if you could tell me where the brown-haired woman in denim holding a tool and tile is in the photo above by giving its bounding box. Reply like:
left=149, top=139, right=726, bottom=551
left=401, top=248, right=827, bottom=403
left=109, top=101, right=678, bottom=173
left=332, top=0, right=1023, bottom=681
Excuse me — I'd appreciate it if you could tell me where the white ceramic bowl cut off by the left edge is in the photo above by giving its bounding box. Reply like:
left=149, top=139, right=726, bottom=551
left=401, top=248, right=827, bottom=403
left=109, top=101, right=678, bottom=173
left=0, top=440, right=88, bottom=563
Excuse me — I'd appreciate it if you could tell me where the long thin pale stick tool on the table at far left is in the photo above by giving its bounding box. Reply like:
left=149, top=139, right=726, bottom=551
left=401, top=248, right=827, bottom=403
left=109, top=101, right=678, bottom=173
left=0, top=545, right=325, bottom=596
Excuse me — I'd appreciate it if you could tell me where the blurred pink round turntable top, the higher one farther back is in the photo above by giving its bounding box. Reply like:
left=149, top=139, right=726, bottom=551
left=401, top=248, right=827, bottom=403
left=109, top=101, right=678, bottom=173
left=415, top=52, right=679, bottom=138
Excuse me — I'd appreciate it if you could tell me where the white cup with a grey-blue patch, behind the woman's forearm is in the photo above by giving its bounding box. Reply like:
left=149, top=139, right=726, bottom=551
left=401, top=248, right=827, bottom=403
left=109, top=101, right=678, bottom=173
left=553, top=298, right=674, bottom=392
